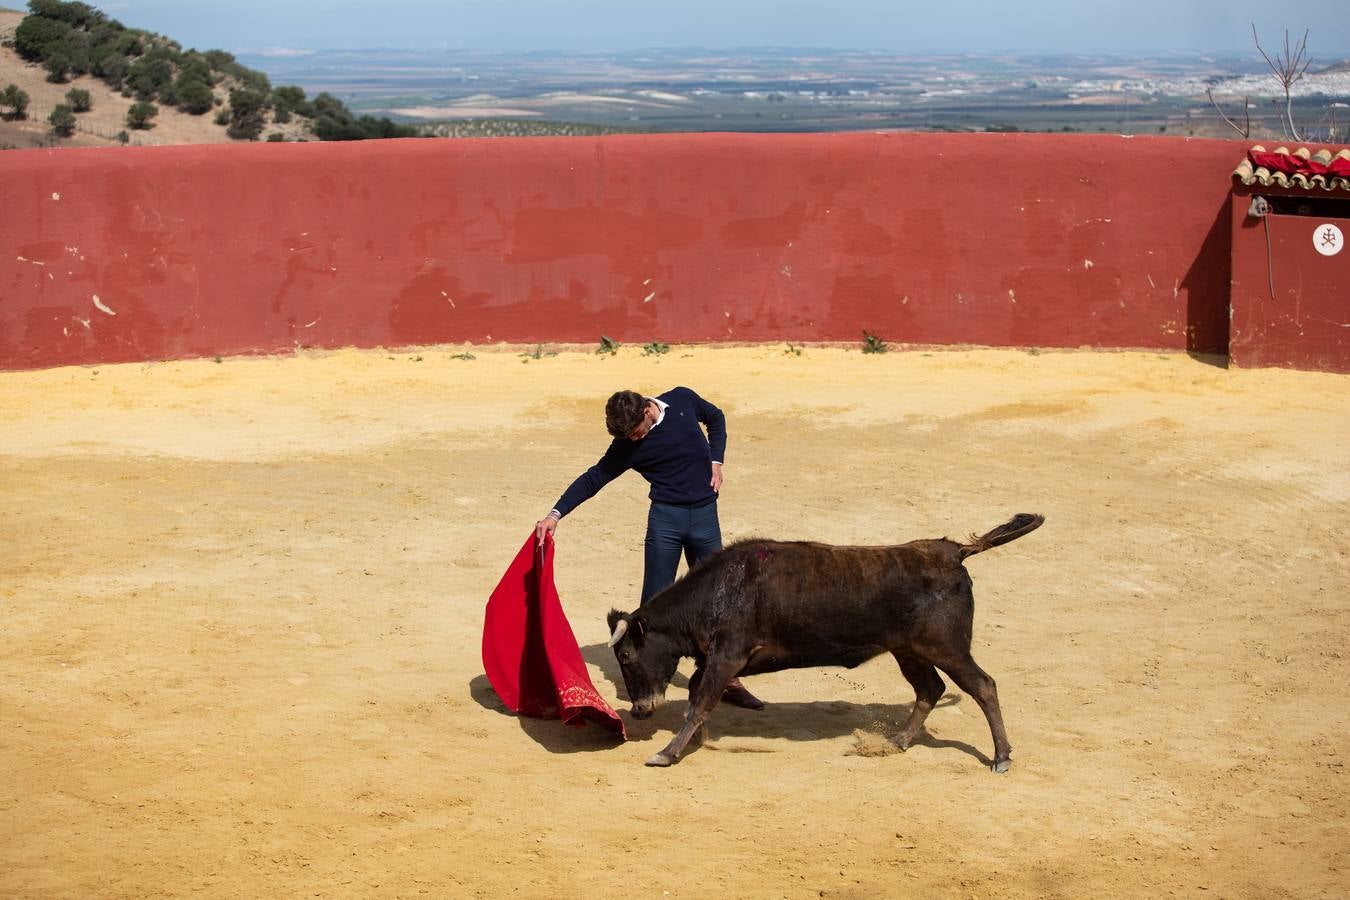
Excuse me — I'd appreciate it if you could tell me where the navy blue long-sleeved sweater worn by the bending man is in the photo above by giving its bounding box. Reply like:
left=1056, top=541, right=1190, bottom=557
left=554, top=387, right=726, bottom=515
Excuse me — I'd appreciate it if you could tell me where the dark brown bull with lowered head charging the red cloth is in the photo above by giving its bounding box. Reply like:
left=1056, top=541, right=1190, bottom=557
left=609, top=513, right=1045, bottom=772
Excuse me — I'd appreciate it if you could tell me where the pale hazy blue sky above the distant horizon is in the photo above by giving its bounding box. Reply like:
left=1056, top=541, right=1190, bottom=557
left=97, top=0, right=1350, bottom=61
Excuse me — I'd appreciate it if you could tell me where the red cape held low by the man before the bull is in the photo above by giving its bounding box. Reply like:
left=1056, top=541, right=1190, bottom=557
left=483, top=530, right=628, bottom=739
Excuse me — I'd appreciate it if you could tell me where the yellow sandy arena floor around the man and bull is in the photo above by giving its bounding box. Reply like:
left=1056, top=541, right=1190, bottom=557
left=0, top=345, right=1350, bottom=899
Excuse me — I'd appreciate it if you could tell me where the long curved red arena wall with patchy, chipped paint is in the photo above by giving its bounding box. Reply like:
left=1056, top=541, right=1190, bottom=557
left=0, top=134, right=1245, bottom=368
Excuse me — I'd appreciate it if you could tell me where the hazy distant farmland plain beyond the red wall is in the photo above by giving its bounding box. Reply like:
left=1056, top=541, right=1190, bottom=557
left=242, top=50, right=1350, bottom=136
